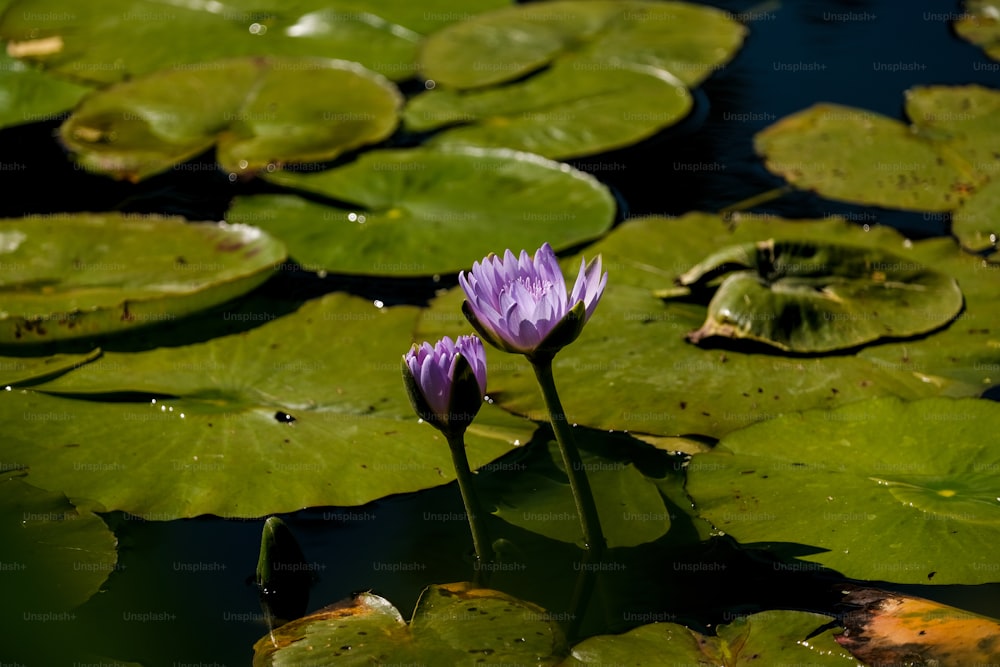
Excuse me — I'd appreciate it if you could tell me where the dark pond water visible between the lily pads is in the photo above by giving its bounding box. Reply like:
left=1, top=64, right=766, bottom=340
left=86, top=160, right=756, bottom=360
left=0, top=0, right=1000, bottom=666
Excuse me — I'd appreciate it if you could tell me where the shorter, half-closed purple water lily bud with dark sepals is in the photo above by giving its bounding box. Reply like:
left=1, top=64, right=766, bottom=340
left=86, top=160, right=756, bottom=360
left=403, top=336, right=486, bottom=436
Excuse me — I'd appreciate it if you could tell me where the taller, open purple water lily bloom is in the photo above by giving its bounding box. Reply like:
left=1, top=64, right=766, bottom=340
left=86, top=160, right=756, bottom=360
left=458, top=243, right=608, bottom=357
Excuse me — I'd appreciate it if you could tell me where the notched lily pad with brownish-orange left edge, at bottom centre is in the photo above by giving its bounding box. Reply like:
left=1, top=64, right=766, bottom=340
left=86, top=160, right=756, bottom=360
left=253, top=584, right=566, bottom=667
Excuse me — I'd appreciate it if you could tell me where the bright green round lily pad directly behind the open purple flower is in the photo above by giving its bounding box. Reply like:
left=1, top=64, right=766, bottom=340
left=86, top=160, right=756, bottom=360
left=226, top=148, right=615, bottom=276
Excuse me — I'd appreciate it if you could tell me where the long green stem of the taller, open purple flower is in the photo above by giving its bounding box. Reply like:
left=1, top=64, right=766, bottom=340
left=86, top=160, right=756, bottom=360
left=529, top=356, right=605, bottom=561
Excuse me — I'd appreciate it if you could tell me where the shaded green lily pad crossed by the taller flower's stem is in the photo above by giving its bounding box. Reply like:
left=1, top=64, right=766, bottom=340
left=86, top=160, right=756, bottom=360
left=483, top=442, right=670, bottom=548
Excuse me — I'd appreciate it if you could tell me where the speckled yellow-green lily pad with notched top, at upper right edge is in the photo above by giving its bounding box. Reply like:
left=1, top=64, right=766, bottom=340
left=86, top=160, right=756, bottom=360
left=754, top=85, right=1000, bottom=211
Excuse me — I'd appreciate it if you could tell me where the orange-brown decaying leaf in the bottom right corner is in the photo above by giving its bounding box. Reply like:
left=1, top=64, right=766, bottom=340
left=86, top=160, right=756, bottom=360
left=837, top=588, right=1000, bottom=665
